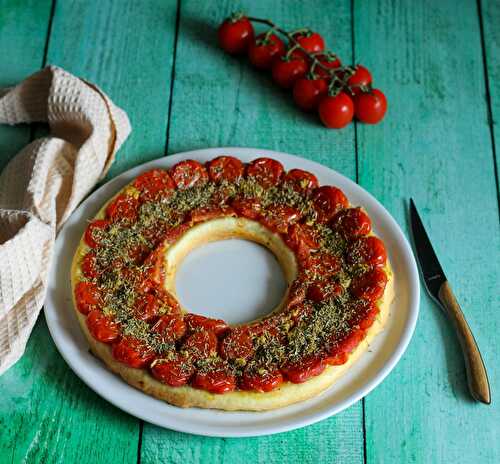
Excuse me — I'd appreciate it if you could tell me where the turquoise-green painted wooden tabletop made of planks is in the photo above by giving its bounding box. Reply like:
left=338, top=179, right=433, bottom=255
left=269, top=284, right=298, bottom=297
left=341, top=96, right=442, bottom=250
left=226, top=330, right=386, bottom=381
left=0, top=0, right=500, bottom=464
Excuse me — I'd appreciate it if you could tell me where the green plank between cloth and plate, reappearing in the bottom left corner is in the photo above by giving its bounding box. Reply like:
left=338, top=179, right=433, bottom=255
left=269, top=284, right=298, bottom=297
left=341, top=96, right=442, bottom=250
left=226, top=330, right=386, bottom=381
left=0, top=1, right=177, bottom=463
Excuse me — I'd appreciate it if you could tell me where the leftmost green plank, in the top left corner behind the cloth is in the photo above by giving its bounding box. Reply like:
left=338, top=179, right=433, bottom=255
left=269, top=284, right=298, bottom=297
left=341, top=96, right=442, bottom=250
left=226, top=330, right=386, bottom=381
left=0, top=0, right=52, bottom=171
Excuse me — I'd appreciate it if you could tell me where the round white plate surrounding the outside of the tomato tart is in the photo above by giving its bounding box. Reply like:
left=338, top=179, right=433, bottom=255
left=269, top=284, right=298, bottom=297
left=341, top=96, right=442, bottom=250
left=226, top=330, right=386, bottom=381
left=45, top=148, right=419, bottom=437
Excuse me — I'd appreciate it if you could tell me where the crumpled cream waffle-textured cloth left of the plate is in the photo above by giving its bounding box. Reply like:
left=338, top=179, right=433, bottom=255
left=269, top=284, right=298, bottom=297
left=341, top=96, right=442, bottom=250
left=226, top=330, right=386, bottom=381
left=0, top=66, right=130, bottom=374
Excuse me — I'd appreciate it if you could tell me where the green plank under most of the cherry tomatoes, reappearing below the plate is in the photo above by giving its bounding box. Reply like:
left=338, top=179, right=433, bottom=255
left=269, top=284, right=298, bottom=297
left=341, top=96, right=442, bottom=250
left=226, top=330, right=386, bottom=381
left=141, top=0, right=363, bottom=464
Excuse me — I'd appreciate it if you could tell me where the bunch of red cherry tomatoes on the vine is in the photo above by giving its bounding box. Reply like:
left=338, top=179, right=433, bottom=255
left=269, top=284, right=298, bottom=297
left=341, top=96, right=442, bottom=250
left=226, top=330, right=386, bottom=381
left=218, top=13, right=387, bottom=129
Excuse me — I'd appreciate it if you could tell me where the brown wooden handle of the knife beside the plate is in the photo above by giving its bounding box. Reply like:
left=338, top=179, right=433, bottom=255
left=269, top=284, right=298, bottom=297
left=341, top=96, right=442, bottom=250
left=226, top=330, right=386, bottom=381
left=438, top=281, right=491, bottom=404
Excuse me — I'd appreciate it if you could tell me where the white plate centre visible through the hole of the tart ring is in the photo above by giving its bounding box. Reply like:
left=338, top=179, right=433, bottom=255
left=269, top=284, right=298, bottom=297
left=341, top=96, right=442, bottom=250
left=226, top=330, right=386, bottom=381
left=175, top=239, right=287, bottom=324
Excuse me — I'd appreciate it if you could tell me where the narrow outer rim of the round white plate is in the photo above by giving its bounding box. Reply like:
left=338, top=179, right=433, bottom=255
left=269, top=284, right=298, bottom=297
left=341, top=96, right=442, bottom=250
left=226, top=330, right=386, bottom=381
left=44, top=147, right=420, bottom=438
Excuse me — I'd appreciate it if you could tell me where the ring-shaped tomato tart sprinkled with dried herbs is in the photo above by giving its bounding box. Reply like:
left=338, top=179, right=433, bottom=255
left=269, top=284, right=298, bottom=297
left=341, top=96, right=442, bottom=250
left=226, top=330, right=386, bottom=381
left=71, top=156, right=393, bottom=411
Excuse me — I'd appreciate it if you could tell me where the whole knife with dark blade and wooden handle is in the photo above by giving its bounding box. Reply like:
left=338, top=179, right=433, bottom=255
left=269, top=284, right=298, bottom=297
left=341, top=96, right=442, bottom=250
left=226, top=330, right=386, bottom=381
left=410, top=198, right=491, bottom=404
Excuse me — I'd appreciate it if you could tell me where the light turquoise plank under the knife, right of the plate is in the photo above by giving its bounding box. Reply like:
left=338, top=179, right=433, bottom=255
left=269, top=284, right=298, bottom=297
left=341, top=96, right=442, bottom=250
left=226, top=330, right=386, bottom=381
left=354, top=0, right=500, bottom=463
